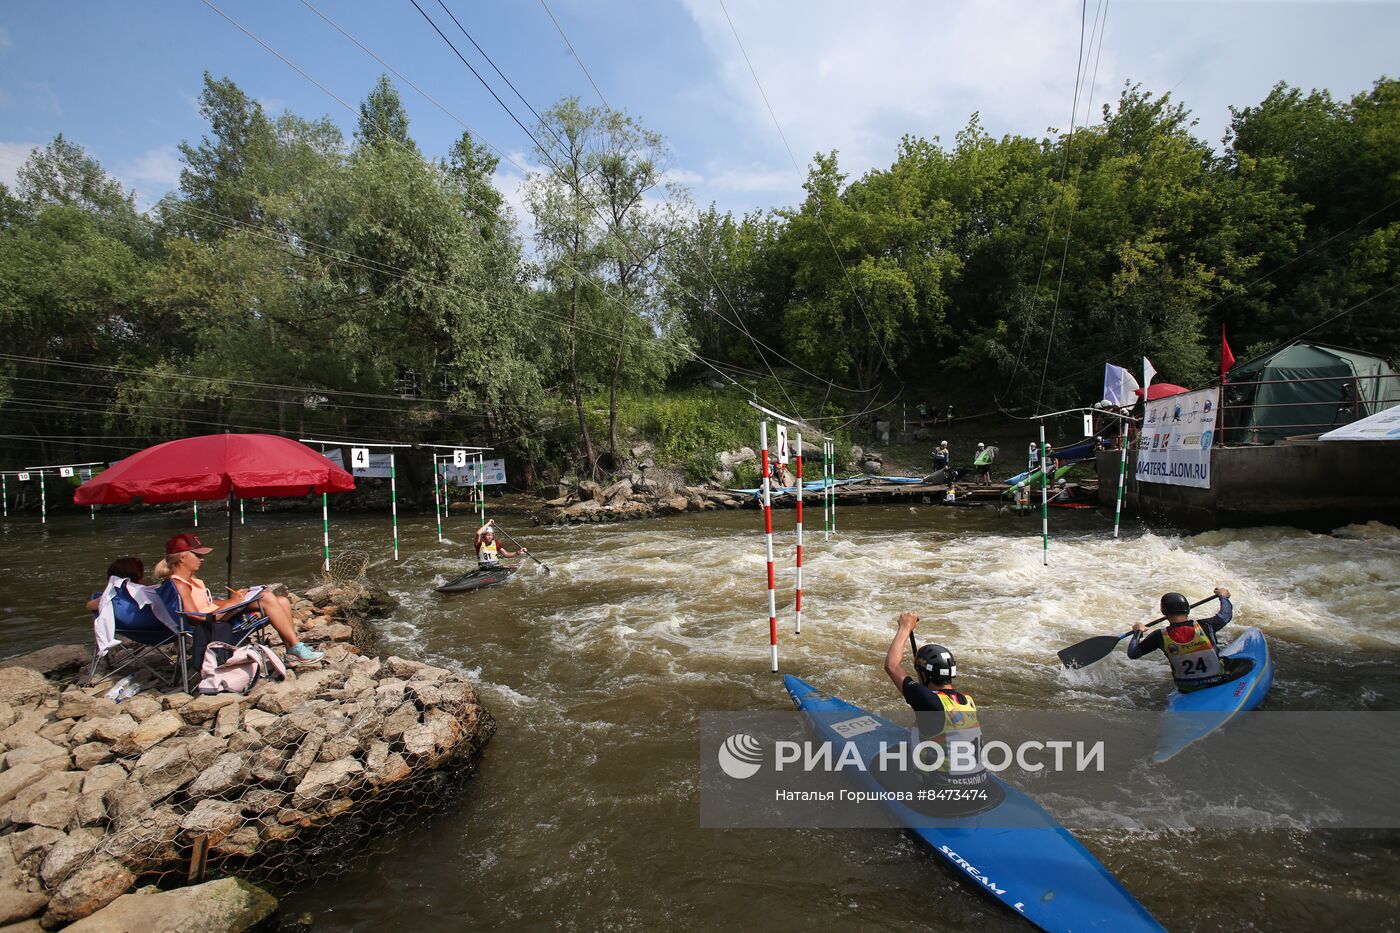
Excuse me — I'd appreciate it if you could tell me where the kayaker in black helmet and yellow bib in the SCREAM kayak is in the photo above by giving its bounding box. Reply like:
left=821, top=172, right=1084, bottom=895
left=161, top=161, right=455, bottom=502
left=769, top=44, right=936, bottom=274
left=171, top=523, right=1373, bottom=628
left=885, top=612, right=987, bottom=785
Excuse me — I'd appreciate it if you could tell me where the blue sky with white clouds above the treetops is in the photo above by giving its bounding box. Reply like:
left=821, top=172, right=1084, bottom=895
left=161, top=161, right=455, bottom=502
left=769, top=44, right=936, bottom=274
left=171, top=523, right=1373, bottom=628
left=0, top=0, right=1400, bottom=218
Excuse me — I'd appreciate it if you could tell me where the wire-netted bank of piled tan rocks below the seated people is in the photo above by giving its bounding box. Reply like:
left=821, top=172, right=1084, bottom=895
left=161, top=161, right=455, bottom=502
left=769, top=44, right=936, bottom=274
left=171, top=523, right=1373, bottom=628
left=0, top=587, right=496, bottom=930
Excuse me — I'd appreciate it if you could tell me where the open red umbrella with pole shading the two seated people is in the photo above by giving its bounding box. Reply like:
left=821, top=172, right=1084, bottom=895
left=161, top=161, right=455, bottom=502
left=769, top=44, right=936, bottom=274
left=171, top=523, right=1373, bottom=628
left=73, top=434, right=354, bottom=583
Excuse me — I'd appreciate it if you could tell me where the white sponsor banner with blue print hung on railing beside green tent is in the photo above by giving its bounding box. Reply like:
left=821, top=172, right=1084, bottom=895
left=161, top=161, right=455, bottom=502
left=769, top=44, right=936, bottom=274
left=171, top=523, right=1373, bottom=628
left=1137, top=387, right=1219, bottom=489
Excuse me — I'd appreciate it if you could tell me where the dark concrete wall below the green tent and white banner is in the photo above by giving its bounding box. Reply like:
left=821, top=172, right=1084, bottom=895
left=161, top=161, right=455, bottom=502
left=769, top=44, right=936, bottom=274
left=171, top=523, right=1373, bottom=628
left=1098, top=441, right=1400, bottom=530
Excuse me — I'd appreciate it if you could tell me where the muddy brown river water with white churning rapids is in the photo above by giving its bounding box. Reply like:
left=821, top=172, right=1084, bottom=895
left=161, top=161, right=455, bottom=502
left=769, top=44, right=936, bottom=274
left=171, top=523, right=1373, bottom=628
left=0, top=506, right=1400, bottom=930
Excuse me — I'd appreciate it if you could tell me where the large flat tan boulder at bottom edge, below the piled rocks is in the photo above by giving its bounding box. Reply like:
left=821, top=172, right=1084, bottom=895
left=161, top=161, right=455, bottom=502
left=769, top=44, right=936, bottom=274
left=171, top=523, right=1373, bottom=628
left=69, top=878, right=277, bottom=933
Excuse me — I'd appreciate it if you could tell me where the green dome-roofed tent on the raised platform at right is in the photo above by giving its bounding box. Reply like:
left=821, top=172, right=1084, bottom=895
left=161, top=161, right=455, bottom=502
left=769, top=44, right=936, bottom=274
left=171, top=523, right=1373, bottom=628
left=1224, top=342, right=1400, bottom=444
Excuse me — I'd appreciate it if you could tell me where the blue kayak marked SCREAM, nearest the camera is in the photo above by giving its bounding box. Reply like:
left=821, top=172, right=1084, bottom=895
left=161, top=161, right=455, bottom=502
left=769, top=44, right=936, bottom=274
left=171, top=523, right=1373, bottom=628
left=783, top=674, right=1162, bottom=930
